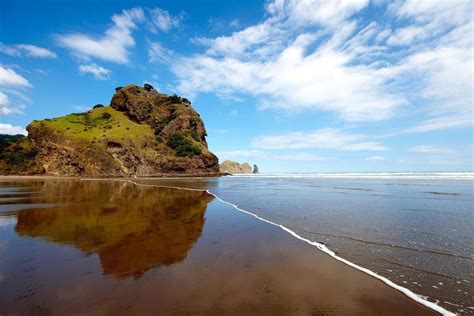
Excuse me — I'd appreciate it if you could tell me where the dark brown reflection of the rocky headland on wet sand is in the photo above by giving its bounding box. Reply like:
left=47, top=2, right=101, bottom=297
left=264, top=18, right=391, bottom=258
left=9, top=180, right=213, bottom=278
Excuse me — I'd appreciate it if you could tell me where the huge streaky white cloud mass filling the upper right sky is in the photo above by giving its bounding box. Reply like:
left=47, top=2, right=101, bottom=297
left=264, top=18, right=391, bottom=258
left=172, top=0, right=473, bottom=127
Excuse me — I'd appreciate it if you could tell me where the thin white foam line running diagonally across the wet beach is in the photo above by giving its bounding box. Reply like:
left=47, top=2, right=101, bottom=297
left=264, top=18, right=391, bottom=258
left=81, top=178, right=457, bottom=316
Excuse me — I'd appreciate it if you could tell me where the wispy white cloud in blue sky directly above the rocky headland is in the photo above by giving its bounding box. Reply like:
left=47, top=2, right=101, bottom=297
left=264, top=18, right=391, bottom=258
left=57, top=8, right=145, bottom=64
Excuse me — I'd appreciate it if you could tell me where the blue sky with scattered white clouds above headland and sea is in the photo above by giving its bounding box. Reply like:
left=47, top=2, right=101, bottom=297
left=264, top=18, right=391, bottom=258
left=0, top=0, right=474, bottom=173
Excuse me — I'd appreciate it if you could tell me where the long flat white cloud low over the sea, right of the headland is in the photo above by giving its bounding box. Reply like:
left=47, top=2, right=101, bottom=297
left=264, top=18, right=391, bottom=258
left=252, top=128, right=389, bottom=151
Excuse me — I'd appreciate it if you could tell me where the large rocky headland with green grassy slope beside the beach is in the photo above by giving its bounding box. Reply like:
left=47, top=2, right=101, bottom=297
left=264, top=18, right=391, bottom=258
left=0, top=84, right=219, bottom=176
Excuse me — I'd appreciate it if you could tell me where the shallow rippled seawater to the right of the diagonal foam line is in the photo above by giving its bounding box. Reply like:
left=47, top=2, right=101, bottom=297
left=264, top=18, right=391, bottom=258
left=140, top=174, right=474, bottom=314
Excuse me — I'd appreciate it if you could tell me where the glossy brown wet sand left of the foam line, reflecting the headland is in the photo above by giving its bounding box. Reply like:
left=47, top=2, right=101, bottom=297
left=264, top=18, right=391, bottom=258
left=0, top=179, right=435, bottom=315
